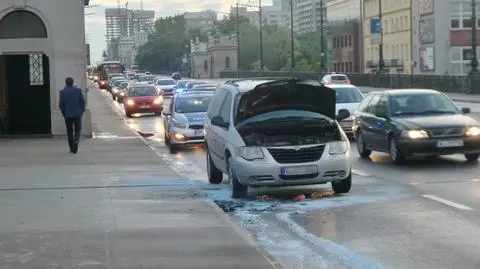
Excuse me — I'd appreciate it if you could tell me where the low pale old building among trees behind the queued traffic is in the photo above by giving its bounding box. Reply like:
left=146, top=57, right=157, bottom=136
left=190, top=35, right=238, bottom=79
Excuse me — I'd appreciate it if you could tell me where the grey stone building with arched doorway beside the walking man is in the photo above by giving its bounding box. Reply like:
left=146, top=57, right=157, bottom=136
left=0, top=0, right=92, bottom=137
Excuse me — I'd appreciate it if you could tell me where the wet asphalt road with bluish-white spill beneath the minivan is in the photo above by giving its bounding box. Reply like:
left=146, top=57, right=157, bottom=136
left=98, top=83, right=480, bottom=269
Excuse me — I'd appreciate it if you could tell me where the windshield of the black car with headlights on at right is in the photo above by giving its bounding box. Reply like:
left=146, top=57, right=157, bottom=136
left=389, top=93, right=460, bottom=116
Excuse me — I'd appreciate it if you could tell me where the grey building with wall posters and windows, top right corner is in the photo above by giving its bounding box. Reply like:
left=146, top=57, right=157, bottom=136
left=412, top=0, right=480, bottom=75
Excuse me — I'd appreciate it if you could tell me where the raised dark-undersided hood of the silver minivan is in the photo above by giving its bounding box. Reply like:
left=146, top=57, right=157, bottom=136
left=235, top=79, right=336, bottom=124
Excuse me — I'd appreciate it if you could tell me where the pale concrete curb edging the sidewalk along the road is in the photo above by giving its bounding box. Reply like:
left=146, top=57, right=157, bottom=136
left=96, top=82, right=286, bottom=269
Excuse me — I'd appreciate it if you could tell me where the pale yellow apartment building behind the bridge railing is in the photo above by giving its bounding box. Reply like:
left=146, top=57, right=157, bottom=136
left=362, top=0, right=415, bottom=73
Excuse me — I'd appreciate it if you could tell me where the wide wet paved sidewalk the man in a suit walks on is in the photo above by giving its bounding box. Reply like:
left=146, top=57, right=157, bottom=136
left=0, top=85, right=281, bottom=269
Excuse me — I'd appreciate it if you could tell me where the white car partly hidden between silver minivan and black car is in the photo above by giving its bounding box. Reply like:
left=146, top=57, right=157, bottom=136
left=328, top=84, right=363, bottom=139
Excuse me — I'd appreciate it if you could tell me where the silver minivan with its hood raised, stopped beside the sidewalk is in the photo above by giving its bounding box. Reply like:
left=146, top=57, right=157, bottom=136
left=205, top=79, right=352, bottom=198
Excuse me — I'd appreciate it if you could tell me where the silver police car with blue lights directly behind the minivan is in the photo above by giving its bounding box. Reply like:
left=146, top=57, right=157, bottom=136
left=163, top=92, right=213, bottom=153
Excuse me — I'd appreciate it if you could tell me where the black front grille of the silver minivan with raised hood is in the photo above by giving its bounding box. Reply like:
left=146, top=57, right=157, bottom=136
left=268, top=145, right=325, bottom=163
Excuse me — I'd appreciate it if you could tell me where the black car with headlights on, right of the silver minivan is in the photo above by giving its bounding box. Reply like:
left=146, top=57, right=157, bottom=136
left=352, top=89, right=480, bottom=163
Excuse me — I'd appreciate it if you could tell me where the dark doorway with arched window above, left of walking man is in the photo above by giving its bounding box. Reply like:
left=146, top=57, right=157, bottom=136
left=0, top=10, right=51, bottom=136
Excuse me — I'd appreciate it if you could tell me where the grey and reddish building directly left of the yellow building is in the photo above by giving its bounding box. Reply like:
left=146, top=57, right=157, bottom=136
left=326, top=0, right=364, bottom=73
